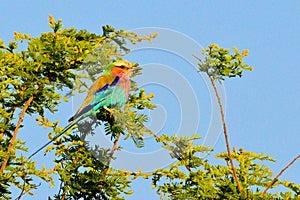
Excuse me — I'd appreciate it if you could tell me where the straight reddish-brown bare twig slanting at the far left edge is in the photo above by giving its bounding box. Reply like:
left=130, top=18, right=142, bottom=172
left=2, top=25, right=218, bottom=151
left=0, top=96, right=34, bottom=173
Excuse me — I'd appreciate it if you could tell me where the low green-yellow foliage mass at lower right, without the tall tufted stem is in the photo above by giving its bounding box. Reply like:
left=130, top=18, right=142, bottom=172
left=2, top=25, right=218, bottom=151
left=152, top=135, right=299, bottom=200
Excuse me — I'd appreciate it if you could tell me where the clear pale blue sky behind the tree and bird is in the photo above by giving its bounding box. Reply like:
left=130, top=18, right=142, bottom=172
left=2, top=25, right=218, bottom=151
left=0, top=0, right=300, bottom=199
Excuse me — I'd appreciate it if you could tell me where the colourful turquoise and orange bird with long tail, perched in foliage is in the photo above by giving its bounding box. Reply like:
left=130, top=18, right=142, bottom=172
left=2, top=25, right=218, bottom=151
left=28, top=59, right=141, bottom=158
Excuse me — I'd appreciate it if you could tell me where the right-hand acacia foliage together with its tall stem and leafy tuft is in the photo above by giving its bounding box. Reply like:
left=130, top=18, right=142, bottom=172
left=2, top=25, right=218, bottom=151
left=152, top=44, right=300, bottom=200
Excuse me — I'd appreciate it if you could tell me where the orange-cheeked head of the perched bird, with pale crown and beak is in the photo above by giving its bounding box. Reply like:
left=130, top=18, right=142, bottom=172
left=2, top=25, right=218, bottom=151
left=108, top=60, right=141, bottom=77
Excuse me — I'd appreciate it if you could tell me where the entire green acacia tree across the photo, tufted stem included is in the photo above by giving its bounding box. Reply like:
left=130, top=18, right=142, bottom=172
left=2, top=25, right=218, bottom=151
left=0, top=16, right=300, bottom=199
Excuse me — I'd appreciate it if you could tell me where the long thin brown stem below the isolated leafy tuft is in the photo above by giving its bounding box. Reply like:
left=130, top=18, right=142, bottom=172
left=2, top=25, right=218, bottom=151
left=209, top=76, right=243, bottom=193
